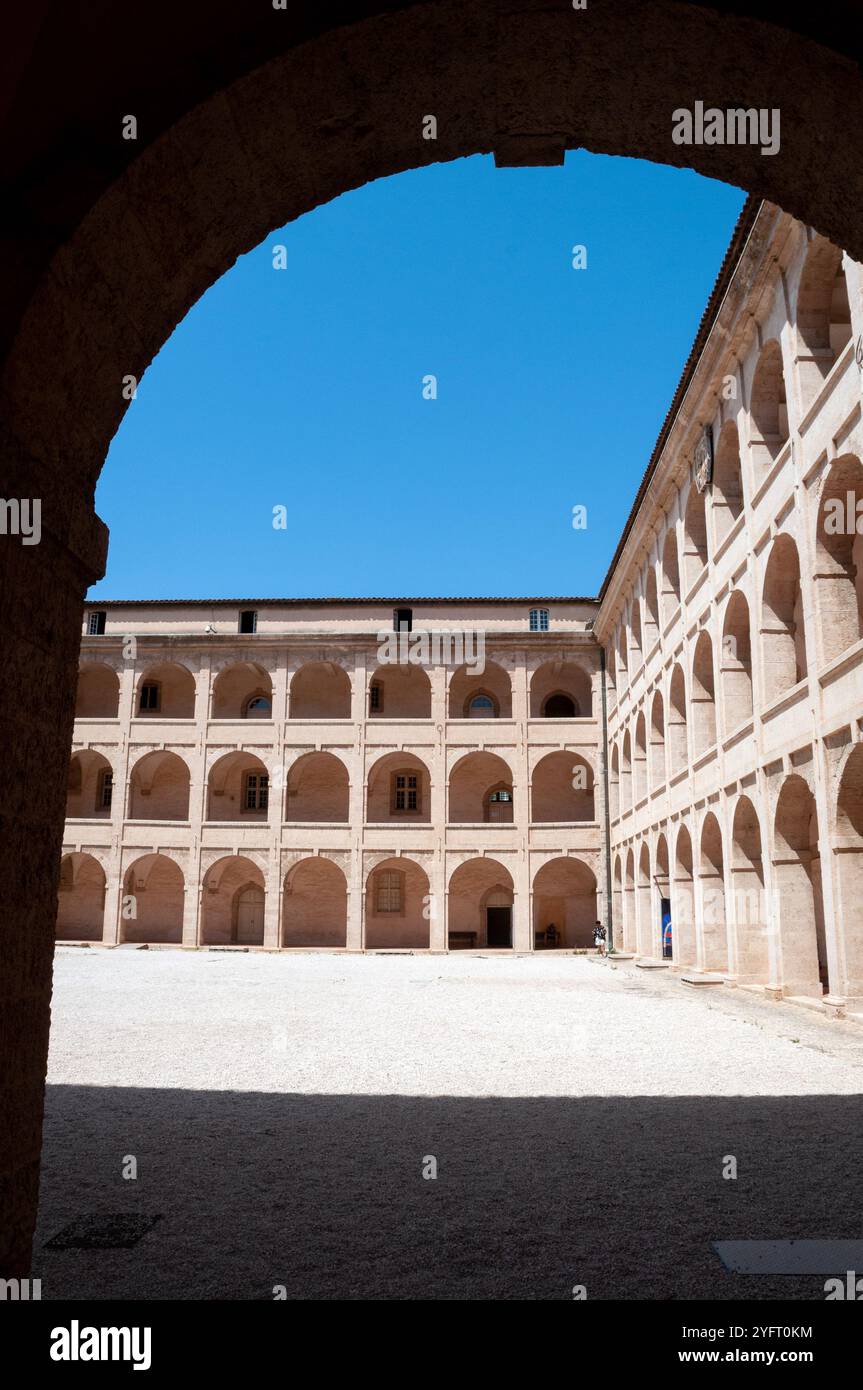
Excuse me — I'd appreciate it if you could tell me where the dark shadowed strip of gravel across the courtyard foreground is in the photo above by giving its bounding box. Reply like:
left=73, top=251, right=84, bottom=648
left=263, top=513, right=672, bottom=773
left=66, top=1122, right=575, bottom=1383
left=33, top=1086, right=863, bottom=1300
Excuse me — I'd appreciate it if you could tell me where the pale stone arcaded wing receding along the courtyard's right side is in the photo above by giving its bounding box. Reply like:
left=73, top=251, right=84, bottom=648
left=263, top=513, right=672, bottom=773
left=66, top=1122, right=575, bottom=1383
left=595, top=204, right=863, bottom=1009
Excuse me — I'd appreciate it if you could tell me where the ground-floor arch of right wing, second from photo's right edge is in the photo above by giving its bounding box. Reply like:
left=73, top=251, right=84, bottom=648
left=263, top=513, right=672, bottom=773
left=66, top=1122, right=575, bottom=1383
left=773, top=773, right=830, bottom=997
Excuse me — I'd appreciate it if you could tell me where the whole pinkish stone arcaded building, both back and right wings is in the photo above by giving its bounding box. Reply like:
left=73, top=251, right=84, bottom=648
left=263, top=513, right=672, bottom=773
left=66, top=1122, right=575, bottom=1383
left=58, top=203, right=863, bottom=1011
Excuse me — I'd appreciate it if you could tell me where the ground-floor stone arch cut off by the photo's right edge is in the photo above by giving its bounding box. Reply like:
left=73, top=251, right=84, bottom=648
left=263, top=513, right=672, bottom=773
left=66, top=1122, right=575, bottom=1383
left=834, top=744, right=863, bottom=1006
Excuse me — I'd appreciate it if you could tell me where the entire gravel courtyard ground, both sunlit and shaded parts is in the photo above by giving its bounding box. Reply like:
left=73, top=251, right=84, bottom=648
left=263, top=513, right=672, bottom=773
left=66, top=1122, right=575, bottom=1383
left=33, top=948, right=863, bottom=1300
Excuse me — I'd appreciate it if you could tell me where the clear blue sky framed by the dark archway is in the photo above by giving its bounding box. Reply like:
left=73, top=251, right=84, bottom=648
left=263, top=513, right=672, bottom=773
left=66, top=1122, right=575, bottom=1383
left=92, top=152, right=743, bottom=598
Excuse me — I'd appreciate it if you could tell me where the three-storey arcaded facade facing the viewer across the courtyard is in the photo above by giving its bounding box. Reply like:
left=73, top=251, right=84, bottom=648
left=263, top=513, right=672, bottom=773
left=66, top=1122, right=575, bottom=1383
left=58, top=599, right=605, bottom=951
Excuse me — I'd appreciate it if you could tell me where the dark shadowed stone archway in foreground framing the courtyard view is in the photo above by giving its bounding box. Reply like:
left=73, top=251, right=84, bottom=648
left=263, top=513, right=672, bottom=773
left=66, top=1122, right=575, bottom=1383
left=0, top=0, right=863, bottom=1275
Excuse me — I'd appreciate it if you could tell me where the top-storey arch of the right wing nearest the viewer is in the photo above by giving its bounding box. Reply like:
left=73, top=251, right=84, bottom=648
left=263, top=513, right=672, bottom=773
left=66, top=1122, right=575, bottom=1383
left=796, top=235, right=852, bottom=410
